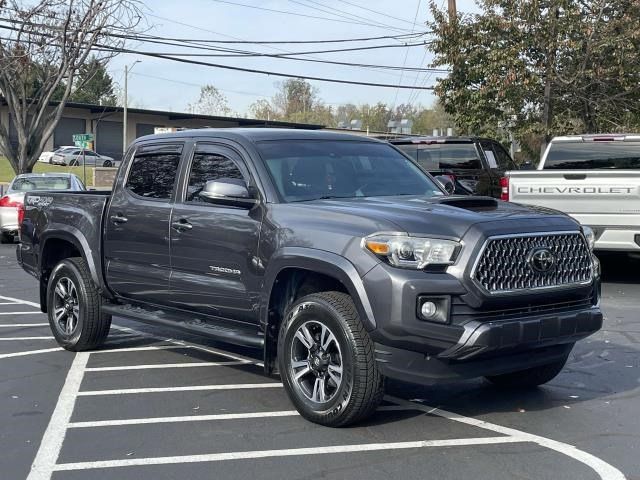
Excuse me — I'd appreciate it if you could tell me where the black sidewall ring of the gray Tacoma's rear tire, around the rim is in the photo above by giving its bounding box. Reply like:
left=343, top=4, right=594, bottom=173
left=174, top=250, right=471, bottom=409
left=47, top=260, right=88, bottom=348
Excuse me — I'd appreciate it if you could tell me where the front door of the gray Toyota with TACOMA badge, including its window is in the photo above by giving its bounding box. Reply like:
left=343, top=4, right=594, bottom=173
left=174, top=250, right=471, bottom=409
left=170, top=143, right=262, bottom=323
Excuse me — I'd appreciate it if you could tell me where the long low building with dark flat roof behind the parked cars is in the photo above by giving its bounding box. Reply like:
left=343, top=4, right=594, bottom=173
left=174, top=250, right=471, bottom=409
left=0, top=102, right=324, bottom=160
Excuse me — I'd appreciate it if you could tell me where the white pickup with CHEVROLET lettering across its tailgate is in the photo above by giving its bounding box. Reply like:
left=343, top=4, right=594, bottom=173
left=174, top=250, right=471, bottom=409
left=501, top=134, right=640, bottom=252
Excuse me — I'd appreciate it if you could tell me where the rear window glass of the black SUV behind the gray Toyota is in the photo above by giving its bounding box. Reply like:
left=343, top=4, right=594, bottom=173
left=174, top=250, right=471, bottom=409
left=398, top=143, right=482, bottom=171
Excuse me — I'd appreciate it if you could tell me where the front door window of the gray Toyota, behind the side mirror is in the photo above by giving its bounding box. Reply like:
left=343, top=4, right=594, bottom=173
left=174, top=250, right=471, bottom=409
left=185, top=145, right=245, bottom=202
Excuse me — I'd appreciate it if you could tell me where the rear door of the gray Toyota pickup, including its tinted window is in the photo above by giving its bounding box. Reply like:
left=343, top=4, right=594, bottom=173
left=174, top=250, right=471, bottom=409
left=104, top=142, right=184, bottom=305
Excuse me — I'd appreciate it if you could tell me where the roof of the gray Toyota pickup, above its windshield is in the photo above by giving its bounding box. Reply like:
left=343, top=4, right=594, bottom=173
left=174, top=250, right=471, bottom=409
left=135, top=128, right=381, bottom=143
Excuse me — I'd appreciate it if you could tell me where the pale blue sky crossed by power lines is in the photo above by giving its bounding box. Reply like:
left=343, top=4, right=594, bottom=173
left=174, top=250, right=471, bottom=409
left=108, top=0, right=476, bottom=116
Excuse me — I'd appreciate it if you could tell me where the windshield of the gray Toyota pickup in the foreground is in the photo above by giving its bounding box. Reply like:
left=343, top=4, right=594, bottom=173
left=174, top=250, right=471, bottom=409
left=258, top=140, right=443, bottom=202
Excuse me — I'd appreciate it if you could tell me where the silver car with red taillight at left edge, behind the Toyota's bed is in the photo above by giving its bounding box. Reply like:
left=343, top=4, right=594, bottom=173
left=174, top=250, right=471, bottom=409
left=0, top=173, right=86, bottom=243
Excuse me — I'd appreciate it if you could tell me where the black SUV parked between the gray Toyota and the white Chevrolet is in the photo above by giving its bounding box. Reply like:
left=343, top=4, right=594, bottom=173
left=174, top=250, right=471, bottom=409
left=389, top=137, right=518, bottom=198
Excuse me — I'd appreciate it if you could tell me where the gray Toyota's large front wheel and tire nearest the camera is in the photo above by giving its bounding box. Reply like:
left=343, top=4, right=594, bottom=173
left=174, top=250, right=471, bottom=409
left=278, top=292, right=384, bottom=427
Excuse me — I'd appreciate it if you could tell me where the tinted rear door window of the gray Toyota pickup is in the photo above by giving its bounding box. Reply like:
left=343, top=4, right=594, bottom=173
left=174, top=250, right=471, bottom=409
left=125, top=145, right=182, bottom=200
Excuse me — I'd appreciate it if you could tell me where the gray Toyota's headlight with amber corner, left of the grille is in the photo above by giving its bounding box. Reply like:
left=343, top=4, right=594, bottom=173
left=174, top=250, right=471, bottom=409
left=364, top=235, right=461, bottom=270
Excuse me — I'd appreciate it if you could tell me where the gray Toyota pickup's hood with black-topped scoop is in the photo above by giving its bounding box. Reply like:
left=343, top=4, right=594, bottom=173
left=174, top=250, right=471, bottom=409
left=296, top=196, right=576, bottom=238
